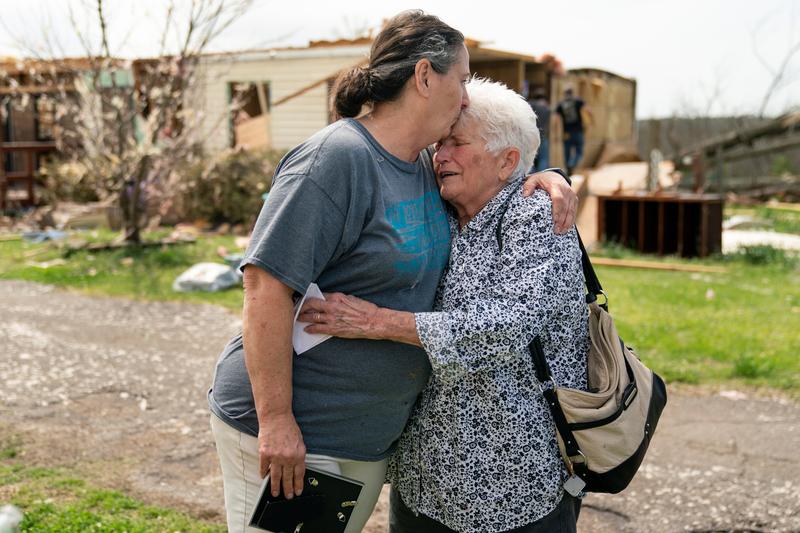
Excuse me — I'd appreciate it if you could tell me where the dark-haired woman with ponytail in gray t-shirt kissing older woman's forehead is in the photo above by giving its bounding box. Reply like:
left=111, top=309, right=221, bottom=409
left=208, top=11, right=577, bottom=532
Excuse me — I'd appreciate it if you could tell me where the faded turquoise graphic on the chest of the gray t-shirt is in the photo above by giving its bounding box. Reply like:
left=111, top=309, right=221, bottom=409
left=386, top=192, right=450, bottom=272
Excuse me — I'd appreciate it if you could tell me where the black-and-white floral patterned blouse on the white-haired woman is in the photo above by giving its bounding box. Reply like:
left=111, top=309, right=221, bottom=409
left=389, top=179, right=589, bottom=533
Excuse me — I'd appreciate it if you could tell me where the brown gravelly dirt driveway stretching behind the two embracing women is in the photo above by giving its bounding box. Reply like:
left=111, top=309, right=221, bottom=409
left=0, top=281, right=800, bottom=533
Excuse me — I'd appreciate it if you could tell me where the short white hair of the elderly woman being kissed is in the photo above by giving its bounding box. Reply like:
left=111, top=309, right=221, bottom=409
left=459, top=77, right=541, bottom=175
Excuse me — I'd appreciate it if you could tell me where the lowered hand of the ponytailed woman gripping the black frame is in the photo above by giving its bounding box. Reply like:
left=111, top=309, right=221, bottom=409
left=258, top=415, right=306, bottom=500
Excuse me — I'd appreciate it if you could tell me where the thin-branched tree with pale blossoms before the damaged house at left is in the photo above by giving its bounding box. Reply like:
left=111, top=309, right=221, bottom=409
left=2, top=0, right=252, bottom=243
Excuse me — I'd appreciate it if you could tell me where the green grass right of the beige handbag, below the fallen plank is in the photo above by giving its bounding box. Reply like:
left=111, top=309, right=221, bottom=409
left=597, top=261, right=800, bottom=388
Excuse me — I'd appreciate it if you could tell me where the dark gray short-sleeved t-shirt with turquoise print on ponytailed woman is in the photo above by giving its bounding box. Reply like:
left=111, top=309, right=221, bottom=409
left=209, top=119, right=450, bottom=461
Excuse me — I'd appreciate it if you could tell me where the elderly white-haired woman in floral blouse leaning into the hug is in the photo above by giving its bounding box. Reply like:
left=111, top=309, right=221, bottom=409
left=304, top=79, right=589, bottom=533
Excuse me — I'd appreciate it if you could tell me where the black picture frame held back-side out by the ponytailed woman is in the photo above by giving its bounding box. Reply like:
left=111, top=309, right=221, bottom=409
left=250, top=468, right=364, bottom=533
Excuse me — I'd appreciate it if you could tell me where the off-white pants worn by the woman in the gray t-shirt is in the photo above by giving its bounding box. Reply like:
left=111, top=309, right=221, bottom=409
left=211, top=414, right=389, bottom=533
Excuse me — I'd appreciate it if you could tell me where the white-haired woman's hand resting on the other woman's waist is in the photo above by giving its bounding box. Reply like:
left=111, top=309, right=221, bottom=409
left=298, top=292, right=380, bottom=339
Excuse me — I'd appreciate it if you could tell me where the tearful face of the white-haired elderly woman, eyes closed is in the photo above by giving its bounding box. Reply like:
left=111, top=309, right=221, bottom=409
left=434, top=120, right=505, bottom=218
